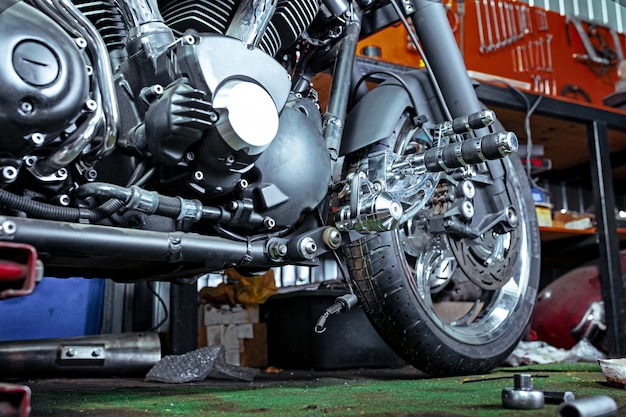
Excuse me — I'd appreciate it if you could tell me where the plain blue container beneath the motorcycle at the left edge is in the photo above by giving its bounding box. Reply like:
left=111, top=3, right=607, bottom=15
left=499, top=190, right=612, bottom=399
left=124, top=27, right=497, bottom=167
left=0, top=278, right=105, bottom=341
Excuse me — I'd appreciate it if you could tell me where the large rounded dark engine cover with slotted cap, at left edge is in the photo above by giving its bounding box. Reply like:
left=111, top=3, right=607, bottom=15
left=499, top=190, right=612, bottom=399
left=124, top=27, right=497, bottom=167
left=0, top=0, right=89, bottom=158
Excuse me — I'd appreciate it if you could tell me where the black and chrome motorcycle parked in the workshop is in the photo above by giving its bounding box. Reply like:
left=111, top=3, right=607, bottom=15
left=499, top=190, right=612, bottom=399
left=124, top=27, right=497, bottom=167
left=0, top=0, right=539, bottom=375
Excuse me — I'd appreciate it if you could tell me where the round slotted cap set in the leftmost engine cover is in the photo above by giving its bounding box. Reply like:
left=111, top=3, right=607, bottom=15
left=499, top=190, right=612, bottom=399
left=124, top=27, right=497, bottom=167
left=13, top=40, right=59, bottom=86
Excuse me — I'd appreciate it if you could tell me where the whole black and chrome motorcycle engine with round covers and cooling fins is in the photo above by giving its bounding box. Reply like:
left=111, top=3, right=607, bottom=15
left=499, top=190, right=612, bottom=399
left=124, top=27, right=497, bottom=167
left=0, top=0, right=330, bottom=230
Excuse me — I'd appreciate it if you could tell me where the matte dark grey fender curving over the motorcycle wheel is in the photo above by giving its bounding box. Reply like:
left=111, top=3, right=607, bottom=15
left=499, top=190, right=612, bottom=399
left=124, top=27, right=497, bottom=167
left=340, top=70, right=443, bottom=155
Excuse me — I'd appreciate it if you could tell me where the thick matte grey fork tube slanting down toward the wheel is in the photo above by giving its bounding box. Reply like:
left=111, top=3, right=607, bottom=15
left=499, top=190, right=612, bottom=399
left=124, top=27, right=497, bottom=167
left=411, top=0, right=482, bottom=118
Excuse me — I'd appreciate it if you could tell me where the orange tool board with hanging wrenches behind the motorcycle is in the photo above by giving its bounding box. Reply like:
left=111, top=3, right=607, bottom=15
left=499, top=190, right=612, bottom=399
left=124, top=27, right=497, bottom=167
left=358, top=0, right=626, bottom=107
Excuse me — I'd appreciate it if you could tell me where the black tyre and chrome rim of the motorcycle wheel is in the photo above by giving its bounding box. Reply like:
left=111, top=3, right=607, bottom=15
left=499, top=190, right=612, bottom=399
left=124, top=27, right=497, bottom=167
left=344, top=119, right=540, bottom=376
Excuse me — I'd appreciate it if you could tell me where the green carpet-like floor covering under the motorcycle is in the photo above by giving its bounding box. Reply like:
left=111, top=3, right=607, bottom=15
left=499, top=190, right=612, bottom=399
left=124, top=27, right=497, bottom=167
left=26, top=363, right=626, bottom=417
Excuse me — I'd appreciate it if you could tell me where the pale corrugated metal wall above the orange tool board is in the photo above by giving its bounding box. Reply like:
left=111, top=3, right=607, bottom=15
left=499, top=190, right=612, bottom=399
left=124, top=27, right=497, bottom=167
left=518, top=0, right=626, bottom=33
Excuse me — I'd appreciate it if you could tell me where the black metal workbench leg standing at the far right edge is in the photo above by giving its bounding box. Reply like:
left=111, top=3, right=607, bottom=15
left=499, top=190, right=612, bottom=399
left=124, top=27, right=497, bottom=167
left=587, top=121, right=626, bottom=357
